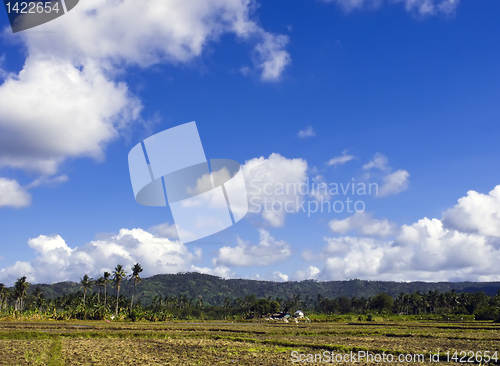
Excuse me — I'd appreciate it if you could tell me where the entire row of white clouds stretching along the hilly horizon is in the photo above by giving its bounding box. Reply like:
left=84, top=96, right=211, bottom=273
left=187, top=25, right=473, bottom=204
left=0, top=186, right=500, bottom=284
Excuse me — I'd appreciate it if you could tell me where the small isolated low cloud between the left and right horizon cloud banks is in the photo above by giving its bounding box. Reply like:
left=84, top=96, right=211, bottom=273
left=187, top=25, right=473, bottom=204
left=214, top=229, right=292, bottom=266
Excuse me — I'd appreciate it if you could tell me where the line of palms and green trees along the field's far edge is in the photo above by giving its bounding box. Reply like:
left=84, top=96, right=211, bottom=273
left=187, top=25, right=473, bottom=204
left=0, top=263, right=500, bottom=321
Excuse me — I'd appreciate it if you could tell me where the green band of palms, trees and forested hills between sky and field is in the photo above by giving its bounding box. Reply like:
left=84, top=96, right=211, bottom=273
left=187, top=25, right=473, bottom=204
left=0, top=270, right=500, bottom=321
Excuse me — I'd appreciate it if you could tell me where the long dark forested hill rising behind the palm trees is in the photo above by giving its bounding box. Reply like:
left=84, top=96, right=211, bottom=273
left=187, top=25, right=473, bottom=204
left=28, top=273, right=500, bottom=306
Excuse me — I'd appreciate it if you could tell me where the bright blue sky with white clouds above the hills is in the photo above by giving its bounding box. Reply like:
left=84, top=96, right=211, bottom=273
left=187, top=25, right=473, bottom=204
left=0, top=0, right=500, bottom=284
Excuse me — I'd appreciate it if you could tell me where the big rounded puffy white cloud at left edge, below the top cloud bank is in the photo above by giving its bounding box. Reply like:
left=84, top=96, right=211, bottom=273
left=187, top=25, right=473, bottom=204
left=0, top=57, right=141, bottom=174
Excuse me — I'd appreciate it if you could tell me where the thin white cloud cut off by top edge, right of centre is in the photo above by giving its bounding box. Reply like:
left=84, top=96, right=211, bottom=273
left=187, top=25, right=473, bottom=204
left=323, top=0, right=459, bottom=16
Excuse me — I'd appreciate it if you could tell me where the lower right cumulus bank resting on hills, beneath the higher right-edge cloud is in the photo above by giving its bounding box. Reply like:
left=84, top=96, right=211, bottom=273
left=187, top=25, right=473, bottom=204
left=314, top=218, right=500, bottom=281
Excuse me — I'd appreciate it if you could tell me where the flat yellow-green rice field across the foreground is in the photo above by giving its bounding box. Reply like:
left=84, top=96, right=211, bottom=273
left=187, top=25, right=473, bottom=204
left=0, top=321, right=500, bottom=366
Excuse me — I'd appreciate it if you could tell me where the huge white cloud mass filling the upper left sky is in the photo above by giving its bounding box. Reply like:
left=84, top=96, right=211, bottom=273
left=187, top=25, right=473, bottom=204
left=0, top=0, right=290, bottom=182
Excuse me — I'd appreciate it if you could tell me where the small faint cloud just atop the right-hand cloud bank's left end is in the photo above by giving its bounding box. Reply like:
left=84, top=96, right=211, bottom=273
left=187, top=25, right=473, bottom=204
left=328, top=212, right=395, bottom=237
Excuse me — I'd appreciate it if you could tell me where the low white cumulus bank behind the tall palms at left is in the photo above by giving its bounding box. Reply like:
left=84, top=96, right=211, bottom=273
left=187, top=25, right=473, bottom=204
left=0, top=229, right=202, bottom=284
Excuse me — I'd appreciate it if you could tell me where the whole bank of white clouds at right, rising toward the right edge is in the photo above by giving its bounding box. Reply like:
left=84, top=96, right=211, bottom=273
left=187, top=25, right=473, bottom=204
left=303, top=186, right=500, bottom=281
